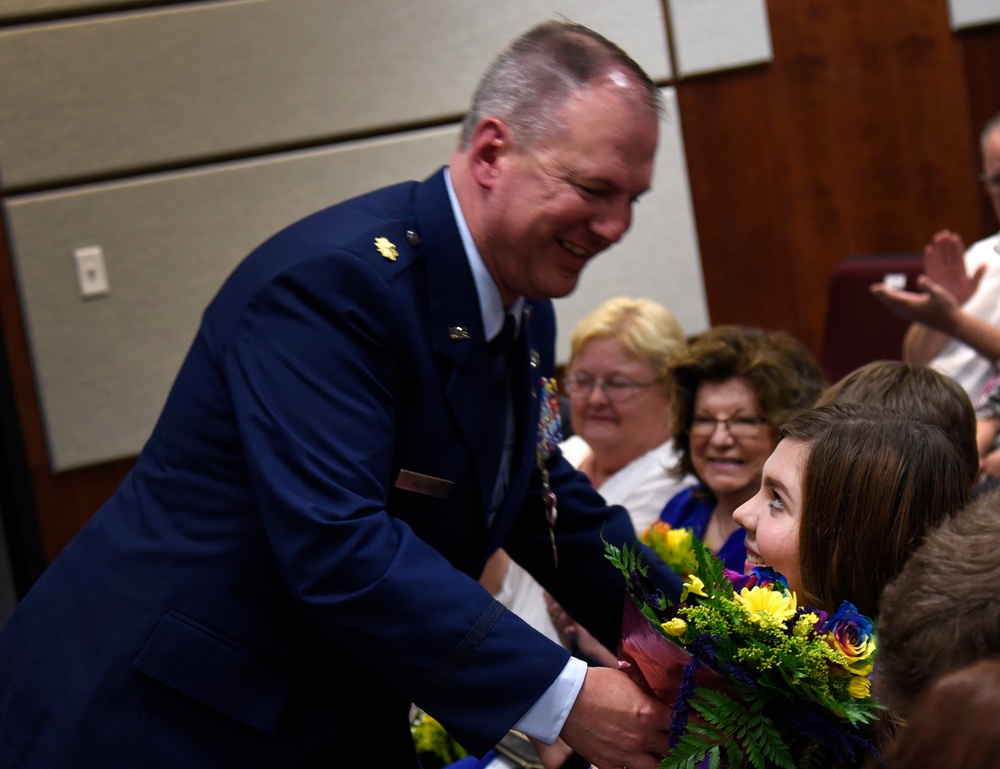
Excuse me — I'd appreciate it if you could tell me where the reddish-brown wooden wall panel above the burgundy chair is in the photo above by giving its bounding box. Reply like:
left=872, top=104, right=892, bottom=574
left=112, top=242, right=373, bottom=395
left=678, top=0, right=979, bottom=354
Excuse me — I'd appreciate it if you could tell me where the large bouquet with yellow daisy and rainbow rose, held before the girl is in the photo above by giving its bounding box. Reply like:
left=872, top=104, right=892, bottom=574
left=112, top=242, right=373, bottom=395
left=605, top=539, right=879, bottom=769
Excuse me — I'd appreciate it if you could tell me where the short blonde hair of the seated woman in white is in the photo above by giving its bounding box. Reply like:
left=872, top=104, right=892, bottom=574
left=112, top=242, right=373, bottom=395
left=570, top=296, right=685, bottom=383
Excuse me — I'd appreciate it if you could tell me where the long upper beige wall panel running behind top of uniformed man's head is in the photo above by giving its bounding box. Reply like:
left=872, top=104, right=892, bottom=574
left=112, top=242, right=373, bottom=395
left=0, top=0, right=669, bottom=188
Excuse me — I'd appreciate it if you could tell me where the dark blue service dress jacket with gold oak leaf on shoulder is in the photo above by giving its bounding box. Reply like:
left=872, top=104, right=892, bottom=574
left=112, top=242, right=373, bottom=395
left=0, top=172, right=680, bottom=769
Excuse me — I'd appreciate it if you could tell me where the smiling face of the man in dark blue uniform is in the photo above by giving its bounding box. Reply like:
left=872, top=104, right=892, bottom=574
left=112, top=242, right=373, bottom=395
left=477, top=80, right=659, bottom=303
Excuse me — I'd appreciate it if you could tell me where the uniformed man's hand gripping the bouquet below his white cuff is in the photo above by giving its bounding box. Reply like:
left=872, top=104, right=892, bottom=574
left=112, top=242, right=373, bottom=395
left=561, top=667, right=670, bottom=769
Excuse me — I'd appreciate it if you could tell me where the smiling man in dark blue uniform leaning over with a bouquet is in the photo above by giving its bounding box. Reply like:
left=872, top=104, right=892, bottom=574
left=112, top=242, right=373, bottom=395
left=0, top=21, right=680, bottom=769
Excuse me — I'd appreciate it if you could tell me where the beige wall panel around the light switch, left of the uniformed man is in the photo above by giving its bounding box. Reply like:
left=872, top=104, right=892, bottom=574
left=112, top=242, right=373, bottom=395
left=7, top=128, right=457, bottom=471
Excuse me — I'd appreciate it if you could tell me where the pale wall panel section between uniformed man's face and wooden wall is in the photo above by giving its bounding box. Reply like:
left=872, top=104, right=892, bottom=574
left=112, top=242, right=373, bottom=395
left=555, top=88, right=709, bottom=362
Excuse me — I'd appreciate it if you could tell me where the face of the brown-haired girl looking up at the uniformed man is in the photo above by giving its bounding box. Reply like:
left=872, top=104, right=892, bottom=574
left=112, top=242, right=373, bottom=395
left=733, top=438, right=809, bottom=595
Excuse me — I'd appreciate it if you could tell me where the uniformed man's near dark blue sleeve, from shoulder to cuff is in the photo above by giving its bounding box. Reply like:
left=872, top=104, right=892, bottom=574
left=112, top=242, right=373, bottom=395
left=222, top=250, right=568, bottom=752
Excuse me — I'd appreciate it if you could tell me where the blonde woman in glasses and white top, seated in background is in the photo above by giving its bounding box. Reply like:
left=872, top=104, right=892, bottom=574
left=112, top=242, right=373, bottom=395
left=483, top=297, right=691, bottom=644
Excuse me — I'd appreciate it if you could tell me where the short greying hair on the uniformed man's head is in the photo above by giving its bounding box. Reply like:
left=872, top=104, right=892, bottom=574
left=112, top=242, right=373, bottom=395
left=460, top=21, right=662, bottom=147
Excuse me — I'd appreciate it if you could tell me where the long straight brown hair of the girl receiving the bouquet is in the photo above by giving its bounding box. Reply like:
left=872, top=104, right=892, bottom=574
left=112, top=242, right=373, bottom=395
left=781, top=402, right=969, bottom=617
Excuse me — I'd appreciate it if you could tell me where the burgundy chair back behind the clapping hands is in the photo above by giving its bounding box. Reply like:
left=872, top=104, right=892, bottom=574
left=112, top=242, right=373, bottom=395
left=819, top=252, right=923, bottom=384
